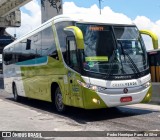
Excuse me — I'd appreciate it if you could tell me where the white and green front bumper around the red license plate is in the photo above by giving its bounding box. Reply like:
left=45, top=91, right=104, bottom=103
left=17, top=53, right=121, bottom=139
left=84, top=86, right=152, bottom=109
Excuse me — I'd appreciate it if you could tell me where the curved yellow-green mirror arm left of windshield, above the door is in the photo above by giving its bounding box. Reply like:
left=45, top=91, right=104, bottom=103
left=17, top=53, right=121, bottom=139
left=64, top=26, right=84, bottom=50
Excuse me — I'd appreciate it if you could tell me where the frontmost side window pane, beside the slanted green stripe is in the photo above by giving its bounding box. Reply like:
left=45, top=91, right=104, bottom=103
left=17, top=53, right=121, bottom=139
left=42, top=27, right=58, bottom=60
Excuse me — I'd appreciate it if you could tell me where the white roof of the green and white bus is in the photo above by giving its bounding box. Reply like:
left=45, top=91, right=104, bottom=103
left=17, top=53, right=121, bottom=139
left=5, top=14, right=135, bottom=49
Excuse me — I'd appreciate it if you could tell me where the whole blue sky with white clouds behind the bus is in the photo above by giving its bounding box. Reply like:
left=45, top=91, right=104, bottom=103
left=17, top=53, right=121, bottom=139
left=7, top=0, right=160, bottom=50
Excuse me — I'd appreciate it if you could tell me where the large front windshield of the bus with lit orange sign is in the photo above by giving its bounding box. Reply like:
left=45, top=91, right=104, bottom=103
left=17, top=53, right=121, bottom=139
left=77, top=23, right=149, bottom=79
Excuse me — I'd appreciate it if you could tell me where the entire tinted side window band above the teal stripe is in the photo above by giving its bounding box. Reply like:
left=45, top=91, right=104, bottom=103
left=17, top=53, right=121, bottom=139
left=3, top=27, right=58, bottom=64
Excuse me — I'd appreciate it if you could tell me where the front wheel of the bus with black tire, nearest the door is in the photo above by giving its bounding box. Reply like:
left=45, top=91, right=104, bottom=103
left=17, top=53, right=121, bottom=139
left=54, top=87, right=66, bottom=113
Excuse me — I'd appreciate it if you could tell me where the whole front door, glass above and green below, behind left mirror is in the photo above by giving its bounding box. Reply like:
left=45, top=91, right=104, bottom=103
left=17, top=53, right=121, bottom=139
left=66, top=37, right=83, bottom=107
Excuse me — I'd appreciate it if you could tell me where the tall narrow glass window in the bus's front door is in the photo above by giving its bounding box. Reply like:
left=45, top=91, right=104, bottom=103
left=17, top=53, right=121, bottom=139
left=67, top=37, right=79, bottom=71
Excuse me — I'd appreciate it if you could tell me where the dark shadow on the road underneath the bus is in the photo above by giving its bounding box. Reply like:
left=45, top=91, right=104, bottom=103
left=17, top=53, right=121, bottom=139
left=6, top=95, right=155, bottom=124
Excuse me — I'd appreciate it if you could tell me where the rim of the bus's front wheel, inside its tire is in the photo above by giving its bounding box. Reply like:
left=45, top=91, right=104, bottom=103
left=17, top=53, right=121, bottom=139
left=55, top=91, right=64, bottom=111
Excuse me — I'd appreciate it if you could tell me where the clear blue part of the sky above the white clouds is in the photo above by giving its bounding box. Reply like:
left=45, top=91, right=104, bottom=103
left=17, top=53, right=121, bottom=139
left=63, top=0, right=160, bottom=21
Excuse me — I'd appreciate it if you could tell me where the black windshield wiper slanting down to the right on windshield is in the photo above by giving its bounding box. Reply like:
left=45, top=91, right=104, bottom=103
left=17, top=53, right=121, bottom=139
left=117, top=40, right=140, bottom=76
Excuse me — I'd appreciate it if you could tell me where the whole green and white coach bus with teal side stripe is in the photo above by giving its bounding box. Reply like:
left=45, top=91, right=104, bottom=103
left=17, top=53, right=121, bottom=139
left=3, top=15, right=155, bottom=112
